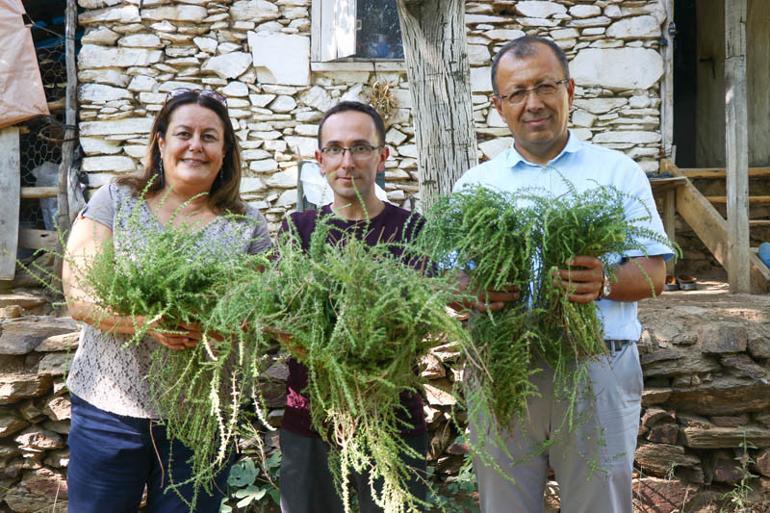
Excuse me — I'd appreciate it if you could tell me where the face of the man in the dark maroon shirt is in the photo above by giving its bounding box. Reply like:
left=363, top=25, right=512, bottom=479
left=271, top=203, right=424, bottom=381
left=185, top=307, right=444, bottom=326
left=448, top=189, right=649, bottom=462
left=315, top=111, right=389, bottom=203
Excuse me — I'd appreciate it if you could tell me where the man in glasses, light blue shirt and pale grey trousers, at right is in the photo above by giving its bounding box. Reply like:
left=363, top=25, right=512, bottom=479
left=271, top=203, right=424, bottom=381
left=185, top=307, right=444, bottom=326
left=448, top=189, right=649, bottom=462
left=455, top=36, right=671, bottom=513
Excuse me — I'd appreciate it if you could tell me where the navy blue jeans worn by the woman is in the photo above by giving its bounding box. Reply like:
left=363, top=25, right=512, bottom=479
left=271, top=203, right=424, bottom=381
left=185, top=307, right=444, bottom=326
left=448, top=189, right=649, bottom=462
left=67, top=395, right=229, bottom=513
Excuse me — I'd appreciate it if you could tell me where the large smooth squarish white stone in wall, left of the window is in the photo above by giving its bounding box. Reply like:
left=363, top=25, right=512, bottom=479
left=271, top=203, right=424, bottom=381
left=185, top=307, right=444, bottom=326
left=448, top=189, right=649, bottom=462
left=248, top=32, right=310, bottom=86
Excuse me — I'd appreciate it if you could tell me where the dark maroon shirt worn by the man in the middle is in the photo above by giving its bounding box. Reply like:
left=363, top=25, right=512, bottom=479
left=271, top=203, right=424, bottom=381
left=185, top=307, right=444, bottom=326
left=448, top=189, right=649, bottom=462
left=281, top=203, right=426, bottom=437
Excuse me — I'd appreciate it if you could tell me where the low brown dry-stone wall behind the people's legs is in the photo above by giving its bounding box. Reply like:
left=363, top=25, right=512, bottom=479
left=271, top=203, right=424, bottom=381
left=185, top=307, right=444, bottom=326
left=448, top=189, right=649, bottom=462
left=0, top=294, right=770, bottom=513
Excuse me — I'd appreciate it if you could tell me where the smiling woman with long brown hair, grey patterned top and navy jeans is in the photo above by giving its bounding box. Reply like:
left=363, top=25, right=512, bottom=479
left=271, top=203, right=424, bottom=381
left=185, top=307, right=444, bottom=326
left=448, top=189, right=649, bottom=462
left=63, top=89, right=270, bottom=513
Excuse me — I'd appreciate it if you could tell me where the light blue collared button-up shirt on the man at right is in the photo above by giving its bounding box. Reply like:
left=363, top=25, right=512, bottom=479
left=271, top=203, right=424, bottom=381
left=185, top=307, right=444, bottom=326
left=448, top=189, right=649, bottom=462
left=454, top=131, right=673, bottom=340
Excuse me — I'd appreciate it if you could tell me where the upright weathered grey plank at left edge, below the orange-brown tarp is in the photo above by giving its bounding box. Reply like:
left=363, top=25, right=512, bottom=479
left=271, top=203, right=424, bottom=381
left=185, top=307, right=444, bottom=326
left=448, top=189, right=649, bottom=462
left=0, top=127, right=21, bottom=280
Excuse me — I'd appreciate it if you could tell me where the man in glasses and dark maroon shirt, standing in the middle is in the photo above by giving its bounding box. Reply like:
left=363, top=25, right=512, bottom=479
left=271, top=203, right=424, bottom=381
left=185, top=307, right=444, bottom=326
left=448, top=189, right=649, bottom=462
left=280, top=102, right=428, bottom=513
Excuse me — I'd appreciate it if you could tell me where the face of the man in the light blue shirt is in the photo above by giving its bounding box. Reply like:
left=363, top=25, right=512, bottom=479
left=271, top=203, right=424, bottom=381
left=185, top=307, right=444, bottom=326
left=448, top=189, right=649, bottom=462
left=492, top=44, right=575, bottom=164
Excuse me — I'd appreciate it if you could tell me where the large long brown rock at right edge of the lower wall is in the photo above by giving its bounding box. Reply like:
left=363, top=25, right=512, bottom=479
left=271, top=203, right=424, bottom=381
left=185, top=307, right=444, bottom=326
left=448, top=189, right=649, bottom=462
left=666, top=376, right=770, bottom=419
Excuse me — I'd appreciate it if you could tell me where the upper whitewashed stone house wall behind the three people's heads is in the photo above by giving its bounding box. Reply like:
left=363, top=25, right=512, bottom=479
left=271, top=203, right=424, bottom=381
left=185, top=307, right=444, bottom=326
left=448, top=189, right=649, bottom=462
left=78, top=0, right=665, bottom=228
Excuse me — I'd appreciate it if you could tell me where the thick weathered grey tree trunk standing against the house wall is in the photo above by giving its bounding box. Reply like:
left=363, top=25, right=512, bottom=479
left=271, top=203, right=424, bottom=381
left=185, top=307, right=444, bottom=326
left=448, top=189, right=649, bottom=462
left=398, top=0, right=478, bottom=209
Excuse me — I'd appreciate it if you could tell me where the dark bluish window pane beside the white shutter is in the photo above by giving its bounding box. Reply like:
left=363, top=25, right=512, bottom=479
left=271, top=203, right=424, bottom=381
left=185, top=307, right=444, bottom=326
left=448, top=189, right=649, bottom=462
left=355, top=0, right=404, bottom=59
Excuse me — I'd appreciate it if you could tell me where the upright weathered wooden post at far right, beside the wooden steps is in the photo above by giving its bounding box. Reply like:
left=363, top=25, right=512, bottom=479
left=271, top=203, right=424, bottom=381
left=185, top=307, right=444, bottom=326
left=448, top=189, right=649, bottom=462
left=725, top=0, right=751, bottom=294
